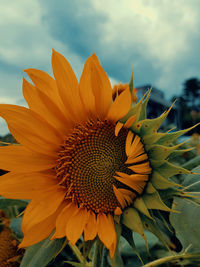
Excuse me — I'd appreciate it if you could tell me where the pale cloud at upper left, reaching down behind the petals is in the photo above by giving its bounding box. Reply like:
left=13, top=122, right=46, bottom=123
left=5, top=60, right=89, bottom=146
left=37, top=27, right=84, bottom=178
left=0, top=0, right=85, bottom=110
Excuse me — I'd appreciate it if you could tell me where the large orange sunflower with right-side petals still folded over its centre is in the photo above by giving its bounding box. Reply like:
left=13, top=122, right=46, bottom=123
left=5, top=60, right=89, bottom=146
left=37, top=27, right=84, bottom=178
left=0, top=50, right=196, bottom=258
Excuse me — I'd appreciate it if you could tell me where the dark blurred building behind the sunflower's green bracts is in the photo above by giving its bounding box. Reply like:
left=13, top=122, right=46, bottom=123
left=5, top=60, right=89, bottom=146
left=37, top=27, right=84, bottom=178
left=136, top=84, right=178, bottom=128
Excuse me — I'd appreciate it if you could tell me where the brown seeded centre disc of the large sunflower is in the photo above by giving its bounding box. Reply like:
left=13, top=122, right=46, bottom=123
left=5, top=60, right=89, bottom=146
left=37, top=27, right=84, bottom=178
left=56, top=120, right=151, bottom=213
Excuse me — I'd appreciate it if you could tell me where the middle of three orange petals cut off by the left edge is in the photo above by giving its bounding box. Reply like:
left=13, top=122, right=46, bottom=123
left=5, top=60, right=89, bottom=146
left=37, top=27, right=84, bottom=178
left=0, top=145, right=56, bottom=172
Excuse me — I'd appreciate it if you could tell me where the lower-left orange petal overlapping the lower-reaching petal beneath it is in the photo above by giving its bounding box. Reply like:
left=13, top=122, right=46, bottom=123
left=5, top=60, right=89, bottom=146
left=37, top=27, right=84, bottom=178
left=22, top=186, right=66, bottom=233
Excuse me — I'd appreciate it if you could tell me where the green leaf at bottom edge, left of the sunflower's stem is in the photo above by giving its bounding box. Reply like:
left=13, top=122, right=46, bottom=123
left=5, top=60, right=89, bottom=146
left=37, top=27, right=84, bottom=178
left=20, top=238, right=65, bottom=267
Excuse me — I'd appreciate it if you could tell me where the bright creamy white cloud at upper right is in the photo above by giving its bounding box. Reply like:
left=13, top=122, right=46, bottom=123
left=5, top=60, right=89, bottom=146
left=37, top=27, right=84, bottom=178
left=93, top=0, right=200, bottom=97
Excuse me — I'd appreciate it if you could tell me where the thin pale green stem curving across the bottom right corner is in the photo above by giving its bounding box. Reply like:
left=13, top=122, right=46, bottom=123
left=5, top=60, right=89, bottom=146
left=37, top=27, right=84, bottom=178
left=143, top=253, right=200, bottom=267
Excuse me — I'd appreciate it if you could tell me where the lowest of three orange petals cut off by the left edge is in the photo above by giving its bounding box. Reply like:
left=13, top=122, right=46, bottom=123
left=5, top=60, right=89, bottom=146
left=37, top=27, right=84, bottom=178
left=0, top=172, right=58, bottom=199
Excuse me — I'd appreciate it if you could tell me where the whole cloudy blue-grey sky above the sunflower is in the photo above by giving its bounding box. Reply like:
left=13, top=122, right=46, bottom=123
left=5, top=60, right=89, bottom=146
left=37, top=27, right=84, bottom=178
left=0, top=0, right=200, bottom=136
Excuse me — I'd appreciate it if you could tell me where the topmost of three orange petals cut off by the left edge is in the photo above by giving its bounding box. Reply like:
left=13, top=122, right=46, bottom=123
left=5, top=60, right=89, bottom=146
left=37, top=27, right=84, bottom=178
left=0, top=104, right=61, bottom=155
